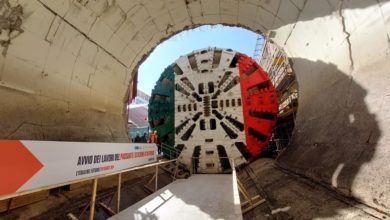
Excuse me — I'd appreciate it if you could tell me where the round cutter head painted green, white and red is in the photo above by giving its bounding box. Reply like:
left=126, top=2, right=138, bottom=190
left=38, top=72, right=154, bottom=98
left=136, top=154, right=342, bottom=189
left=149, top=48, right=278, bottom=173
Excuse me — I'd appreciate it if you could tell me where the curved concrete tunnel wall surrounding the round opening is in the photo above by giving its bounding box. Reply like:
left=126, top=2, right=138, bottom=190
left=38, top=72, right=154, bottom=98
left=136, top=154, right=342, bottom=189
left=0, top=0, right=390, bottom=213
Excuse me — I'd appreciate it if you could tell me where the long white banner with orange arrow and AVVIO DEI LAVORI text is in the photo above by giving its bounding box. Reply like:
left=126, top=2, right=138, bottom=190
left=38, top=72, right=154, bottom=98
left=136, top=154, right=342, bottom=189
left=0, top=140, right=157, bottom=199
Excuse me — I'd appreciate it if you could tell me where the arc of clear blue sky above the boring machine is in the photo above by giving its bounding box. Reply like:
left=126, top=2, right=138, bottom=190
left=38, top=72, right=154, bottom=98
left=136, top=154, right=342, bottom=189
left=138, top=25, right=258, bottom=95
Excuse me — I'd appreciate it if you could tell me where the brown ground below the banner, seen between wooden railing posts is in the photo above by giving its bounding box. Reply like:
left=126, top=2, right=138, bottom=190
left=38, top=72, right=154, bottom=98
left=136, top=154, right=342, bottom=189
left=0, top=167, right=172, bottom=220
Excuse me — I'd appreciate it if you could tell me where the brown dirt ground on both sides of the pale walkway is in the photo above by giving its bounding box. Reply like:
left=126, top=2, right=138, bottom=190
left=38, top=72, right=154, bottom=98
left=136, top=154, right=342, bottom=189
left=0, top=158, right=386, bottom=220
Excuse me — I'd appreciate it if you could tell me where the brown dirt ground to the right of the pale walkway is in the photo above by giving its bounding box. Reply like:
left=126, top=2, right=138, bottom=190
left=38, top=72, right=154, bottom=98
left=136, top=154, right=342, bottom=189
left=237, top=159, right=389, bottom=220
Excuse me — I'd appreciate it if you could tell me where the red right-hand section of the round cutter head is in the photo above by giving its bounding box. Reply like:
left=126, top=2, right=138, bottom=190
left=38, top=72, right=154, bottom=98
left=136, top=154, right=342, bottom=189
left=236, top=53, right=278, bottom=157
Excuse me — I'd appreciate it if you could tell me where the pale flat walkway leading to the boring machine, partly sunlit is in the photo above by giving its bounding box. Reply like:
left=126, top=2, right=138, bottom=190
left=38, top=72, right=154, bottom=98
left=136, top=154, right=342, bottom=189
left=110, top=174, right=242, bottom=220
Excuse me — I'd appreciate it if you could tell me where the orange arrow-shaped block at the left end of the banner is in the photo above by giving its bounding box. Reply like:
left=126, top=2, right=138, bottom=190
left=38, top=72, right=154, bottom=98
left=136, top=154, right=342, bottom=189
left=0, top=140, right=43, bottom=195
